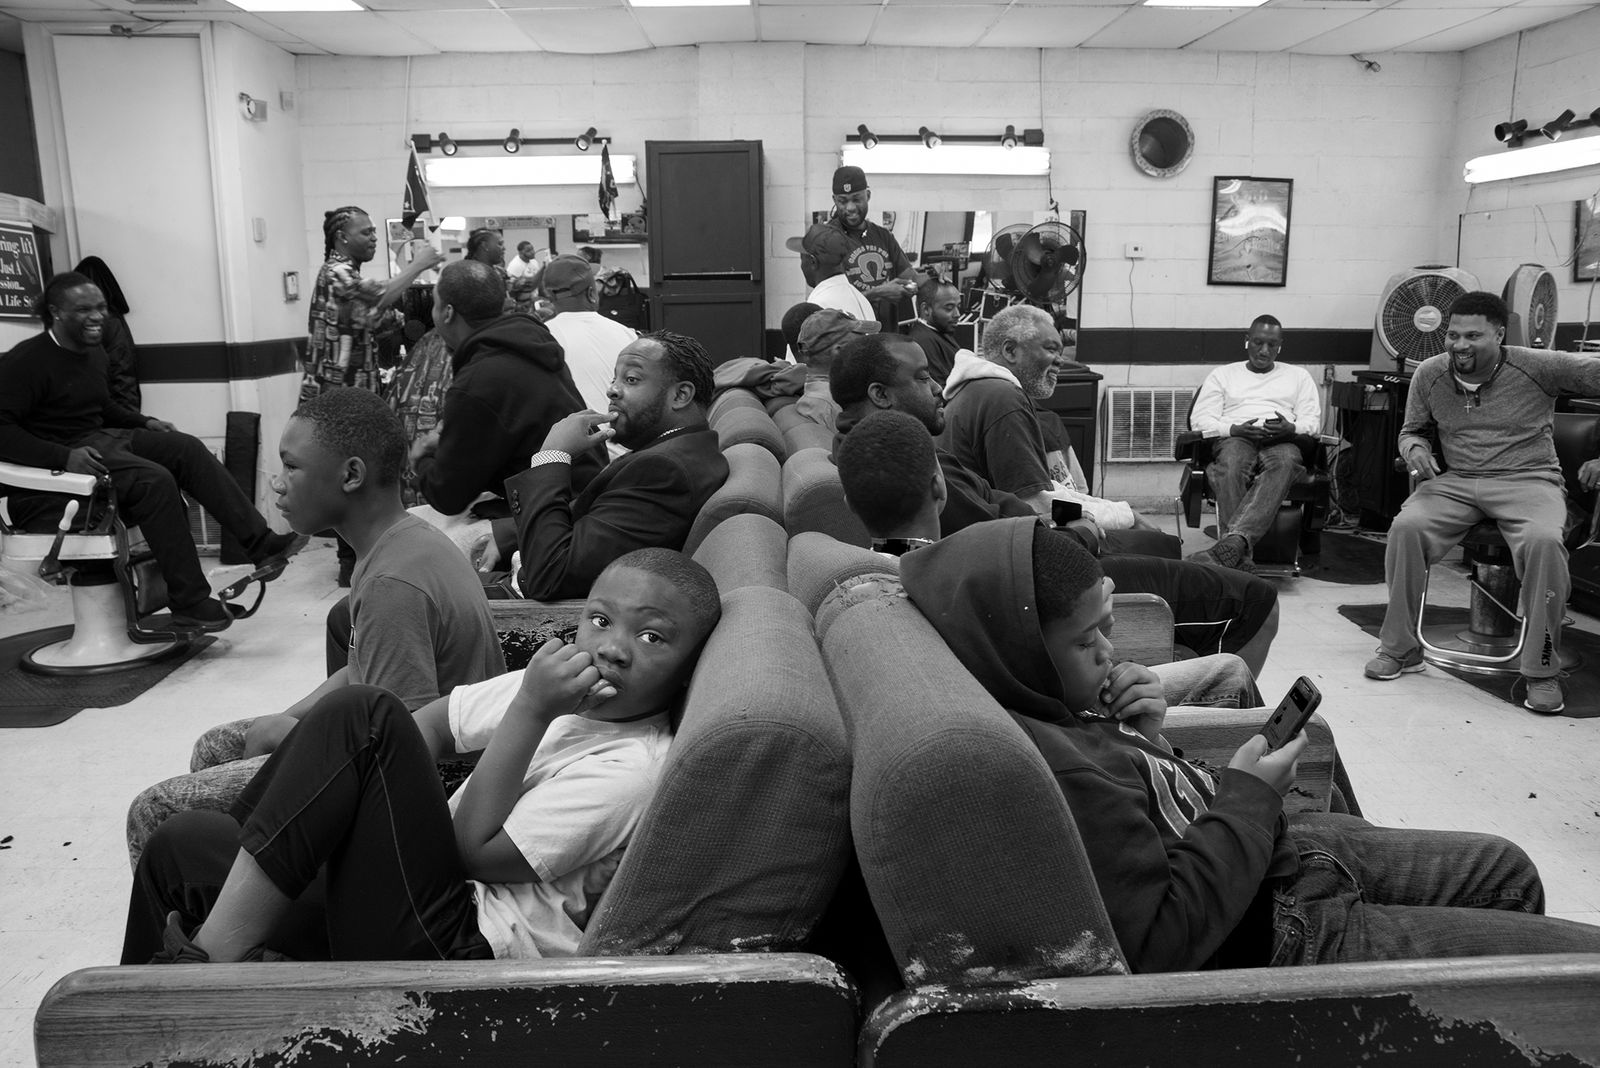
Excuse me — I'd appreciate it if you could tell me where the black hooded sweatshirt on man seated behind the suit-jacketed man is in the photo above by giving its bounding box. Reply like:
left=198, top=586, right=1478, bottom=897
left=416, top=315, right=594, bottom=515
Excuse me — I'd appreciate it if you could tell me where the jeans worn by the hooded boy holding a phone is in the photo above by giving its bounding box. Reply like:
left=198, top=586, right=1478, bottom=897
left=1272, top=814, right=1600, bottom=967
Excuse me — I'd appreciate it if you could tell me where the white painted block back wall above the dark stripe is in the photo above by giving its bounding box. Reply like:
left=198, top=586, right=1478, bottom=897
left=298, top=43, right=1461, bottom=335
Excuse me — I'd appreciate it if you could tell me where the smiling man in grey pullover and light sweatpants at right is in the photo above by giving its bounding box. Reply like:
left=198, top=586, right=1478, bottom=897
left=1366, top=293, right=1600, bottom=713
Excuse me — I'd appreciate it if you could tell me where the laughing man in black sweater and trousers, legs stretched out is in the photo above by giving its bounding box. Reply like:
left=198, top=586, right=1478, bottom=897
left=0, top=272, right=304, bottom=630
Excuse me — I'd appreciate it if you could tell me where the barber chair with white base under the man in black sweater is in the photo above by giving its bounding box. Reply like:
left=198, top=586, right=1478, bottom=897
left=0, top=464, right=202, bottom=675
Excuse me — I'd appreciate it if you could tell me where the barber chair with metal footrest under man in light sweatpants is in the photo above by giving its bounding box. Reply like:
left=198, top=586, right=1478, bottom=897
left=1397, top=412, right=1600, bottom=675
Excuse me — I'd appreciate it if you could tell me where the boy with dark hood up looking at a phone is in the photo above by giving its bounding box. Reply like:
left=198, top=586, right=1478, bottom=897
left=901, top=518, right=1600, bottom=972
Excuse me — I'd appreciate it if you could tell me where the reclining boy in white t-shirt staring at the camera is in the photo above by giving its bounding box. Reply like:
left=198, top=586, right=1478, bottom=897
left=123, top=548, right=722, bottom=964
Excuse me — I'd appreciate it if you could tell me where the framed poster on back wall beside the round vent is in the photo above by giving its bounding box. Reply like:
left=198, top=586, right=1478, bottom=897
left=1206, top=176, right=1294, bottom=286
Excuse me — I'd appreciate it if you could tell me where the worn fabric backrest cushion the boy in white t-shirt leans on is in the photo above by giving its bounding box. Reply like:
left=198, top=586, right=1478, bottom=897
left=579, top=587, right=850, bottom=956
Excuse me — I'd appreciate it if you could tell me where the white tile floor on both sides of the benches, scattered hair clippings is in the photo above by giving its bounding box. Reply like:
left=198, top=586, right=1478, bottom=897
left=0, top=530, right=1600, bottom=1068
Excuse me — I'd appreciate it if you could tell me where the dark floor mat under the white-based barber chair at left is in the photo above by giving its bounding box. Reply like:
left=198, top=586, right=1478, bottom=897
left=0, top=624, right=216, bottom=729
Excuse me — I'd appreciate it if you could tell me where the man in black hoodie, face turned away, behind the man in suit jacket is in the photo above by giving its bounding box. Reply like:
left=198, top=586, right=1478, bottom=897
left=411, top=259, right=598, bottom=534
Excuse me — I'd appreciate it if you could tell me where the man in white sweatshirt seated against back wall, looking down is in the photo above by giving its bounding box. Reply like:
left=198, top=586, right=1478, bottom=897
left=1189, top=315, right=1322, bottom=571
